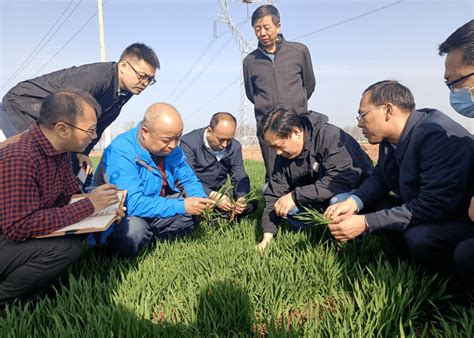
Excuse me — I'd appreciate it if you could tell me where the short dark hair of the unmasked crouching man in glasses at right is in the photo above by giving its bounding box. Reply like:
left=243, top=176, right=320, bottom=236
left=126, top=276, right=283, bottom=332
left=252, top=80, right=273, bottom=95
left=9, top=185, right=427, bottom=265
left=362, top=80, right=415, bottom=111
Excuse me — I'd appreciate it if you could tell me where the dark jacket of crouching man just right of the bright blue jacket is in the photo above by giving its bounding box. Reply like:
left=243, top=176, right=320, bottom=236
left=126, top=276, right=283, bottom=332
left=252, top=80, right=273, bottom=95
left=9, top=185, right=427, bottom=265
left=180, top=128, right=250, bottom=198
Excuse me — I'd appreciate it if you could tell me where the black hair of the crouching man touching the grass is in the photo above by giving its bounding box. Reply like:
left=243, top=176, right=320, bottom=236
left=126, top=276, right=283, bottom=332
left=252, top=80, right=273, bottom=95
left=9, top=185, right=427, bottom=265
left=257, top=105, right=303, bottom=139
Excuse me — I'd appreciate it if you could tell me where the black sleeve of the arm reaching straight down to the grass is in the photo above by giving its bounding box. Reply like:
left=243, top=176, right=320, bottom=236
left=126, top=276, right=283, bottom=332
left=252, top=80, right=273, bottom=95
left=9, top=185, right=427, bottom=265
left=262, top=162, right=290, bottom=235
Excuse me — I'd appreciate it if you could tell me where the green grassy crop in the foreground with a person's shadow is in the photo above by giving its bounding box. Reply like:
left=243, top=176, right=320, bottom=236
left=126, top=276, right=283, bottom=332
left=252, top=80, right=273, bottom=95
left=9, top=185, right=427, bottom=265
left=0, top=162, right=474, bottom=337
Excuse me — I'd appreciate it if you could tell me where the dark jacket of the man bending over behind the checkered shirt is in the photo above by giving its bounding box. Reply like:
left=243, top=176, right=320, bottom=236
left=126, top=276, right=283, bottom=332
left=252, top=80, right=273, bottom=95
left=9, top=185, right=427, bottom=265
left=2, top=62, right=132, bottom=154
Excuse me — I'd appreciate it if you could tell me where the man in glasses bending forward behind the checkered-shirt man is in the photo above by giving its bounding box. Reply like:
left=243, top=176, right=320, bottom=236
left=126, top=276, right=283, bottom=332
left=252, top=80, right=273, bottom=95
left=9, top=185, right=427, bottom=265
left=0, top=43, right=160, bottom=173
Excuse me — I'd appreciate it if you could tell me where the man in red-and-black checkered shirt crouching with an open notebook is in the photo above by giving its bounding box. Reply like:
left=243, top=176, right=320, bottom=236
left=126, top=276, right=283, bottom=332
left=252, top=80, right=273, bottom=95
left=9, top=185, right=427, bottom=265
left=0, top=90, right=123, bottom=309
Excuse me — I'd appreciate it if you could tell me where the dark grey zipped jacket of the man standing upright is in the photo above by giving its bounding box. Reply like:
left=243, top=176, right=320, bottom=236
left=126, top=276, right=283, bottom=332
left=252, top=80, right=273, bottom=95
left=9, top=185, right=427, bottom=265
left=243, top=35, right=316, bottom=124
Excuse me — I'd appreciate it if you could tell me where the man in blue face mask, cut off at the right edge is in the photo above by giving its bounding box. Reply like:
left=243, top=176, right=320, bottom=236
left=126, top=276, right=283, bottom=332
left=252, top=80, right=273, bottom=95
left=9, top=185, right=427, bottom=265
left=439, top=20, right=474, bottom=292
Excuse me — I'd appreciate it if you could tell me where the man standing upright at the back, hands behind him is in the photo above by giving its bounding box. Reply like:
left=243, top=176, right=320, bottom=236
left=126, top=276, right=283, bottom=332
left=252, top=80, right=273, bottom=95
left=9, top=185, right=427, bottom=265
left=243, top=5, right=316, bottom=181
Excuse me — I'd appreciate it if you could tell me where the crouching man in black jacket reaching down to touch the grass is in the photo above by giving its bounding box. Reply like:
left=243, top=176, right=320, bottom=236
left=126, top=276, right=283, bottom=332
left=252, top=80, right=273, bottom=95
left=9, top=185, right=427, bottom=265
left=258, top=106, right=373, bottom=252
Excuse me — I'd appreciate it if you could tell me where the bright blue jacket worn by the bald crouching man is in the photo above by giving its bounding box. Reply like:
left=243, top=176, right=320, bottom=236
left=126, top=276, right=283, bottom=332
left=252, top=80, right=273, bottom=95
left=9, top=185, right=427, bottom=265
left=94, top=125, right=207, bottom=218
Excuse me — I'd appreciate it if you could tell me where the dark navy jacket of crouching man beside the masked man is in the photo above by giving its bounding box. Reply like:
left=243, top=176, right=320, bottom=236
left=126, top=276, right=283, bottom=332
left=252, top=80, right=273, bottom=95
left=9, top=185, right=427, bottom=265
left=354, top=109, right=474, bottom=232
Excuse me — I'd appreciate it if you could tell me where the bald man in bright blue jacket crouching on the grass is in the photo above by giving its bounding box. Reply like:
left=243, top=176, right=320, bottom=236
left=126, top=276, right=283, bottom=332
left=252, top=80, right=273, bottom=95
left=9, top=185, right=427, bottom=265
left=94, top=103, right=213, bottom=258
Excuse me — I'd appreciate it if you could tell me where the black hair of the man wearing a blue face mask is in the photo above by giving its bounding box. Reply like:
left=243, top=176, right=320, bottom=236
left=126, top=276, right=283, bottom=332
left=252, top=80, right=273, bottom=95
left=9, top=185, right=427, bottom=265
left=439, top=20, right=474, bottom=65
